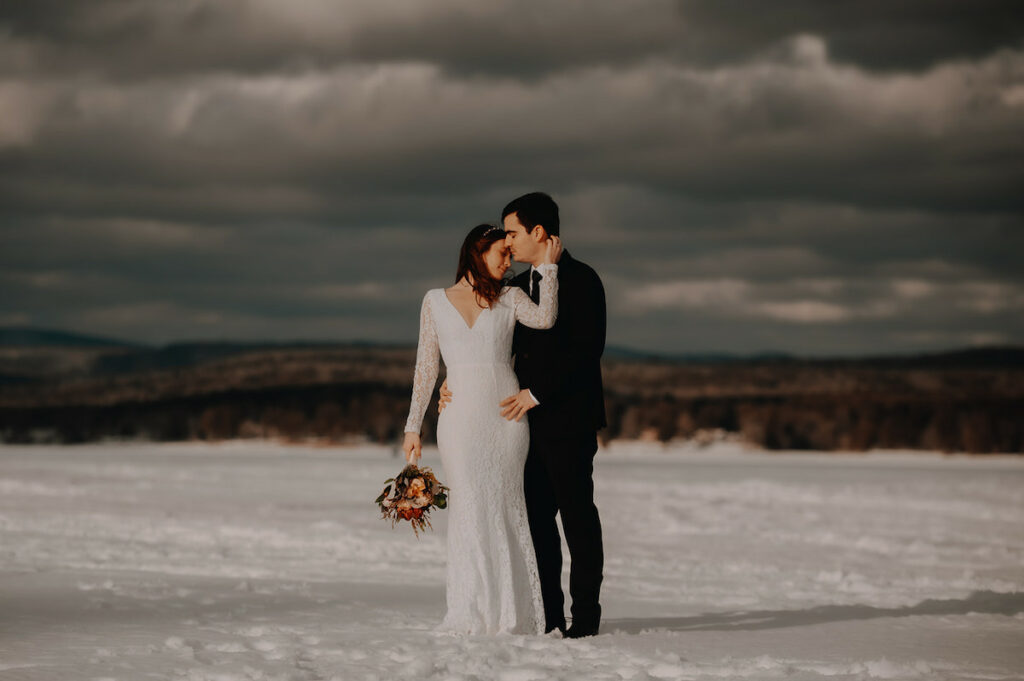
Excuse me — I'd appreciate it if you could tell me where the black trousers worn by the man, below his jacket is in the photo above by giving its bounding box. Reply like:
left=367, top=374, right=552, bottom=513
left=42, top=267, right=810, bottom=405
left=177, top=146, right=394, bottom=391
left=524, top=430, right=604, bottom=628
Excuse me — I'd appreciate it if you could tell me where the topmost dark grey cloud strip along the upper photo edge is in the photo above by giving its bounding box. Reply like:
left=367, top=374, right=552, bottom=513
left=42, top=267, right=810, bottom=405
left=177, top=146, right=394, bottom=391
left=0, top=0, right=1024, bottom=78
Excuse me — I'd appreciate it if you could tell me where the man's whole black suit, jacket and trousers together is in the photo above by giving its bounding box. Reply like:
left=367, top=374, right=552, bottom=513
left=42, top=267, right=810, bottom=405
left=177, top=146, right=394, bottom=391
left=512, top=251, right=606, bottom=628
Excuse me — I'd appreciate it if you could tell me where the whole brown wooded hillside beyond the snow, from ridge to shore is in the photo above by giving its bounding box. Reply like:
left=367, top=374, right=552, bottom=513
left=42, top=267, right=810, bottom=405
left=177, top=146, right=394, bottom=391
left=0, top=347, right=1024, bottom=453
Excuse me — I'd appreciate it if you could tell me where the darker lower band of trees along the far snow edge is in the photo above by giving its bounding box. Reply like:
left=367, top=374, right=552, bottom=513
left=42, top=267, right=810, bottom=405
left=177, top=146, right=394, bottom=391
left=0, top=384, right=1024, bottom=453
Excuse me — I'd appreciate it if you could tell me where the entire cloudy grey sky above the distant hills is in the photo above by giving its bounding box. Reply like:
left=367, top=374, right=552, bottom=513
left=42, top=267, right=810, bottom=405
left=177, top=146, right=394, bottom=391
left=0, top=0, right=1024, bottom=355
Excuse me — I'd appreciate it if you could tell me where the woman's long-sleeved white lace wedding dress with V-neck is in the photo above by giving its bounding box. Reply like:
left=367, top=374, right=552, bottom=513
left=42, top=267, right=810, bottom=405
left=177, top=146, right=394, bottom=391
left=406, top=265, right=558, bottom=634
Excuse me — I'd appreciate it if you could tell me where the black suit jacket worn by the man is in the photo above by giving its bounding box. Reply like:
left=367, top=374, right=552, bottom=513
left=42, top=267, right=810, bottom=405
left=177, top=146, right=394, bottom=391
left=512, top=251, right=607, bottom=437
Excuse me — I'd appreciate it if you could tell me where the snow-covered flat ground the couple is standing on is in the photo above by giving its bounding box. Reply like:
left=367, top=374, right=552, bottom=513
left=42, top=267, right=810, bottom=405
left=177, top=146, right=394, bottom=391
left=0, top=441, right=1024, bottom=681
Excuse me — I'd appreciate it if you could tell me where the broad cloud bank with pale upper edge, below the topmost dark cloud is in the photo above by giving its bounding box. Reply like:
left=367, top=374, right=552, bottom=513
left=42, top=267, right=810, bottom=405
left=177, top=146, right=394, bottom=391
left=0, top=36, right=1024, bottom=215
